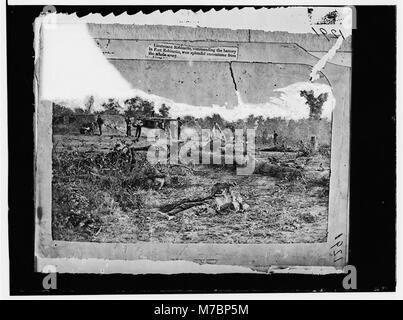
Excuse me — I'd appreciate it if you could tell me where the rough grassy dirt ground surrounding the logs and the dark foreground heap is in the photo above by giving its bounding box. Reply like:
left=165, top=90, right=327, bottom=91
left=52, top=135, right=330, bottom=244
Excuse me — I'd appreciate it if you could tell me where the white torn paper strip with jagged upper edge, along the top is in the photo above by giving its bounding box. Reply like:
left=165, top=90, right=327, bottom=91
left=37, top=5, right=354, bottom=38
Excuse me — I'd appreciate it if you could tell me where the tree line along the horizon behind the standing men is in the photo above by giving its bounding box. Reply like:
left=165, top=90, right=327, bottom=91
left=53, top=90, right=331, bottom=144
